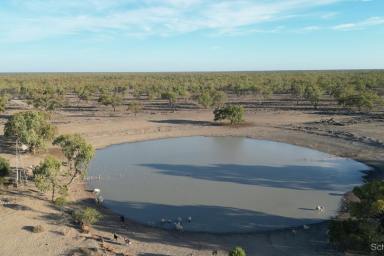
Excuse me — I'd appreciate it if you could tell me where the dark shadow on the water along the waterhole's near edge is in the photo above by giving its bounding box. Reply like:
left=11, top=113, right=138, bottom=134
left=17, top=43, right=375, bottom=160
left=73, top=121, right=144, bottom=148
left=95, top=200, right=323, bottom=234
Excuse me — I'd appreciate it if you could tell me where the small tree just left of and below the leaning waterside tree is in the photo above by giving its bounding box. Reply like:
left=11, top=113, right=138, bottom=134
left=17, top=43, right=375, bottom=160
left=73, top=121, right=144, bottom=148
left=33, top=156, right=61, bottom=202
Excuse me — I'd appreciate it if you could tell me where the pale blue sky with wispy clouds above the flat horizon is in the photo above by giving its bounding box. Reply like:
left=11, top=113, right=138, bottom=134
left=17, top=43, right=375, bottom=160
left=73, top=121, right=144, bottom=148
left=0, top=0, right=384, bottom=72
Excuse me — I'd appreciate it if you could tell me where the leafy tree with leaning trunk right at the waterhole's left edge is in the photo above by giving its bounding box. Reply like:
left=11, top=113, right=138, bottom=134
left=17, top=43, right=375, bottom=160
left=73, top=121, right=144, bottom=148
left=53, top=134, right=95, bottom=186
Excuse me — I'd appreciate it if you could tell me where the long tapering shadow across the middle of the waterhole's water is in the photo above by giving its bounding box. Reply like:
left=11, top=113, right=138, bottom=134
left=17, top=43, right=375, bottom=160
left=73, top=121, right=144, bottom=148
left=140, top=163, right=363, bottom=191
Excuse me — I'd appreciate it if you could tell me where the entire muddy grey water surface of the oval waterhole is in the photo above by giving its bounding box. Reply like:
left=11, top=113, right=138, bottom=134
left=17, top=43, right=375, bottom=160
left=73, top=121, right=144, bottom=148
left=89, top=137, right=368, bottom=232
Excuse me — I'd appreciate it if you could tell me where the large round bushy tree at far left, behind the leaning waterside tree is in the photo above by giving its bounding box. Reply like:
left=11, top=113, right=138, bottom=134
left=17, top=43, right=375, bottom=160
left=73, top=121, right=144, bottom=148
left=4, top=111, right=56, bottom=153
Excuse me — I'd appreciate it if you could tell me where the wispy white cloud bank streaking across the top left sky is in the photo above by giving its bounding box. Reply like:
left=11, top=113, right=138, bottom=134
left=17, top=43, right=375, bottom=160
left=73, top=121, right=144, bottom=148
left=0, top=0, right=341, bottom=41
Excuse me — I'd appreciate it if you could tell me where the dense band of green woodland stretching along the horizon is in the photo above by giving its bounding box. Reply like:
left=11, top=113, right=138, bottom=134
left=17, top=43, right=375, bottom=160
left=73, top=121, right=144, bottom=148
left=0, top=70, right=384, bottom=113
